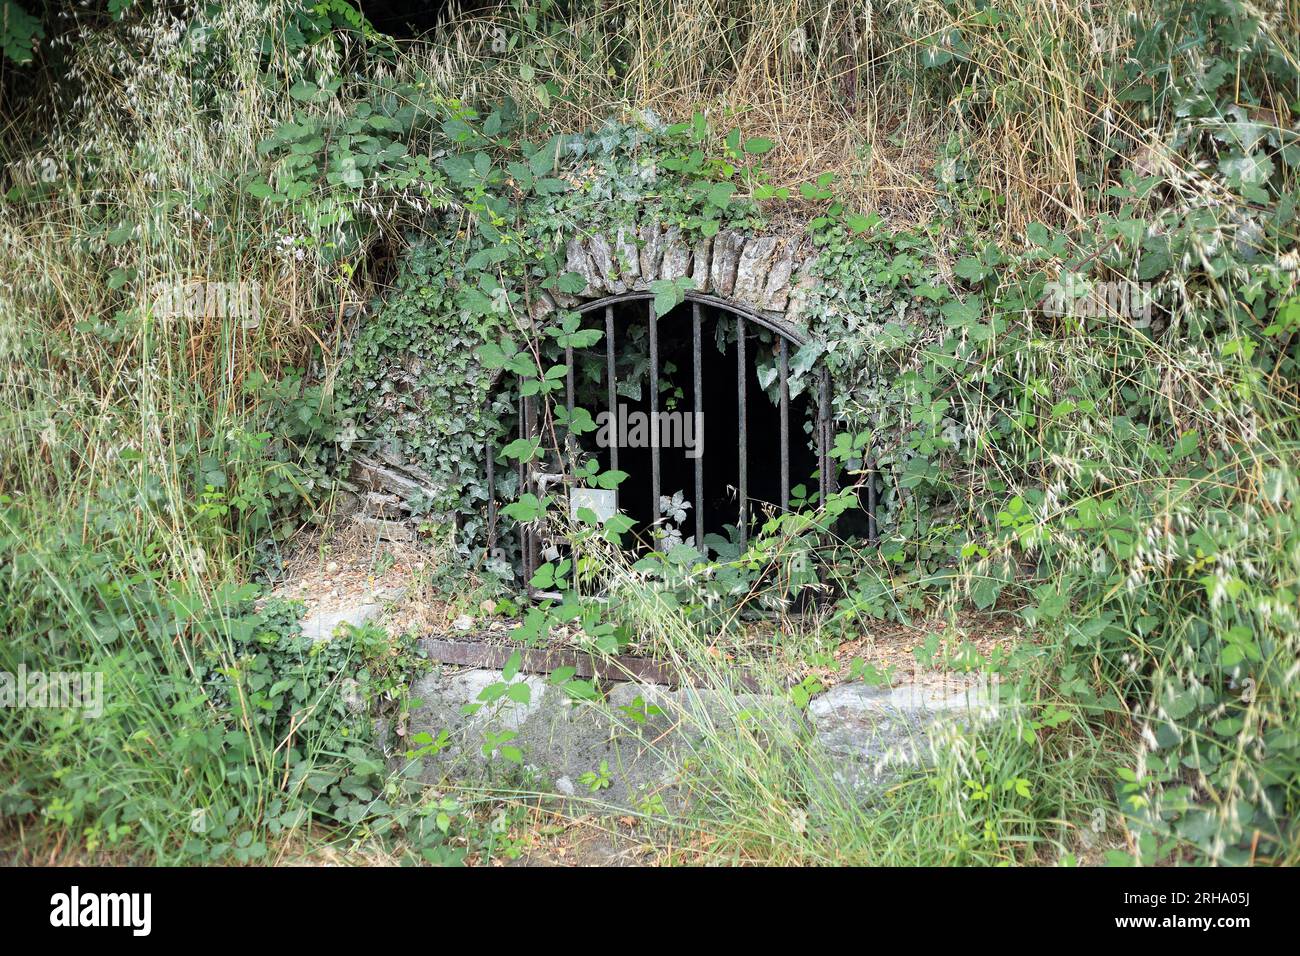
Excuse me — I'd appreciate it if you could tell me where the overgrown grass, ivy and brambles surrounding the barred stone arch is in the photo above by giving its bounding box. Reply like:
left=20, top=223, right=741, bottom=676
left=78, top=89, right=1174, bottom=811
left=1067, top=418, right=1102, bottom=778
left=0, top=0, right=1300, bottom=864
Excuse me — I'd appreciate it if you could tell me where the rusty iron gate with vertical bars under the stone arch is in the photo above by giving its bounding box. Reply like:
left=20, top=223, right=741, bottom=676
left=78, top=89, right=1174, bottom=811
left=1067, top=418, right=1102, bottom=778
left=485, top=291, right=876, bottom=585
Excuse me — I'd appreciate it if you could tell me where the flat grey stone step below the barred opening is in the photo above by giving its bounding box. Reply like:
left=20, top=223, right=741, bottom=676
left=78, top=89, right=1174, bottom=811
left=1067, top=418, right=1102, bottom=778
left=389, top=660, right=995, bottom=812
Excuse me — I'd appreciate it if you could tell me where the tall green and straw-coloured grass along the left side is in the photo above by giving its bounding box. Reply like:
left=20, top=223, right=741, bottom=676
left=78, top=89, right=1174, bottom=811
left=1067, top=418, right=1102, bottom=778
left=0, top=3, right=358, bottom=860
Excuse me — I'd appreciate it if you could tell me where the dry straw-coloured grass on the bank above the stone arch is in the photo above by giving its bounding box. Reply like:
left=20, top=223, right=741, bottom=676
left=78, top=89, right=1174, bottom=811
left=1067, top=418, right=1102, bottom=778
left=402, top=0, right=1145, bottom=233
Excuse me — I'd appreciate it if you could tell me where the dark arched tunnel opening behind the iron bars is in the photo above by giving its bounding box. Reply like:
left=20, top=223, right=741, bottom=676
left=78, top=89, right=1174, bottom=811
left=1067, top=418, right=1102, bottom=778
left=488, top=293, right=837, bottom=590
